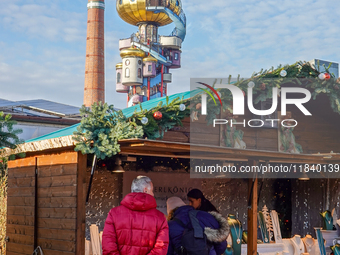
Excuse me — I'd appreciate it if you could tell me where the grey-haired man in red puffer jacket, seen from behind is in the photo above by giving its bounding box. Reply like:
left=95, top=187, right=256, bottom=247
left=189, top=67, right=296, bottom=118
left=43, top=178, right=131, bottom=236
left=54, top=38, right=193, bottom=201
left=102, top=176, right=169, bottom=255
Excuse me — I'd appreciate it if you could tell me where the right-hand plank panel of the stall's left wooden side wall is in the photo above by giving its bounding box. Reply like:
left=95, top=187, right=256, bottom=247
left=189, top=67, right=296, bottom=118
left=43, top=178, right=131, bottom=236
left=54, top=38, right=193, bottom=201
left=38, top=152, right=77, bottom=254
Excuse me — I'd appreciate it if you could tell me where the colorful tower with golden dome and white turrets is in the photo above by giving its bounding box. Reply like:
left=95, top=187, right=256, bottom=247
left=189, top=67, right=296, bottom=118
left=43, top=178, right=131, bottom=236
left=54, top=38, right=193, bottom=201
left=116, top=0, right=186, bottom=106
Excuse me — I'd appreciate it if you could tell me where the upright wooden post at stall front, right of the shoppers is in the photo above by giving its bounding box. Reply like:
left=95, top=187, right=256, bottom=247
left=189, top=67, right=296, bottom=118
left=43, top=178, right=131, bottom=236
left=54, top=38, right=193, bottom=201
left=247, top=160, right=258, bottom=255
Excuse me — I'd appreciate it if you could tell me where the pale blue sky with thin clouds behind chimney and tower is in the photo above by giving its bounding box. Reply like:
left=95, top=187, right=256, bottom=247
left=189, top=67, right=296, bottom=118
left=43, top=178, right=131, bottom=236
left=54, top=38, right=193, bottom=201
left=0, top=0, right=340, bottom=108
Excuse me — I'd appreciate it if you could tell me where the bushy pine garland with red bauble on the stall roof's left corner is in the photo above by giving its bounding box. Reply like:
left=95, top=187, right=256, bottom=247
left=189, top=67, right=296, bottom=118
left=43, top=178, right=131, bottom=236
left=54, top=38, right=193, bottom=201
left=74, top=97, right=190, bottom=159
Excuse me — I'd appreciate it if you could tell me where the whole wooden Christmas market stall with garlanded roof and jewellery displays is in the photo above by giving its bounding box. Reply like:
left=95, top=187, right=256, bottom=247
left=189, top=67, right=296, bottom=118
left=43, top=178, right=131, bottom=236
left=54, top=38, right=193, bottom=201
left=6, top=63, right=340, bottom=255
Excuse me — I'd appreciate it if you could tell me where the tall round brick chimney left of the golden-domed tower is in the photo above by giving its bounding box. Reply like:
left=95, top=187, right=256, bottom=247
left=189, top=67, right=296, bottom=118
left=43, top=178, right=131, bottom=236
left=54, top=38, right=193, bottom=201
left=84, top=0, right=105, bottom=107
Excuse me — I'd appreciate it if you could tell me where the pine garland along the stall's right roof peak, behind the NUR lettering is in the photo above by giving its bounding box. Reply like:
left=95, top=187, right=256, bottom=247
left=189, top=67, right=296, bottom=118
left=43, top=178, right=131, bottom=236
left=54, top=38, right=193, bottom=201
left=192, top=61, right=340, bottom=124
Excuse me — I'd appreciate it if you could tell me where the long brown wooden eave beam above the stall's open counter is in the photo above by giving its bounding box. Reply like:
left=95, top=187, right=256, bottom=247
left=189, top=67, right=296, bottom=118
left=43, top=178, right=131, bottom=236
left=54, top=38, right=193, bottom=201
left=119, top=139, right=340, bottom=164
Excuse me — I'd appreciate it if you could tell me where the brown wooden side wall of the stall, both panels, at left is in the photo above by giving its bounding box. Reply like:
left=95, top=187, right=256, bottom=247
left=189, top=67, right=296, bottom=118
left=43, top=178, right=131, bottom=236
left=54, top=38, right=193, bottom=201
left=7, top=151, right=86, bottom=255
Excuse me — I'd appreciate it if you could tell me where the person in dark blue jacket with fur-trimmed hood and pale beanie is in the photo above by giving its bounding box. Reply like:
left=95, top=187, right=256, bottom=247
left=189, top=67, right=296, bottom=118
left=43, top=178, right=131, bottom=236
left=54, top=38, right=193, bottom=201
left=167, top=197, right=230, bottom=255
